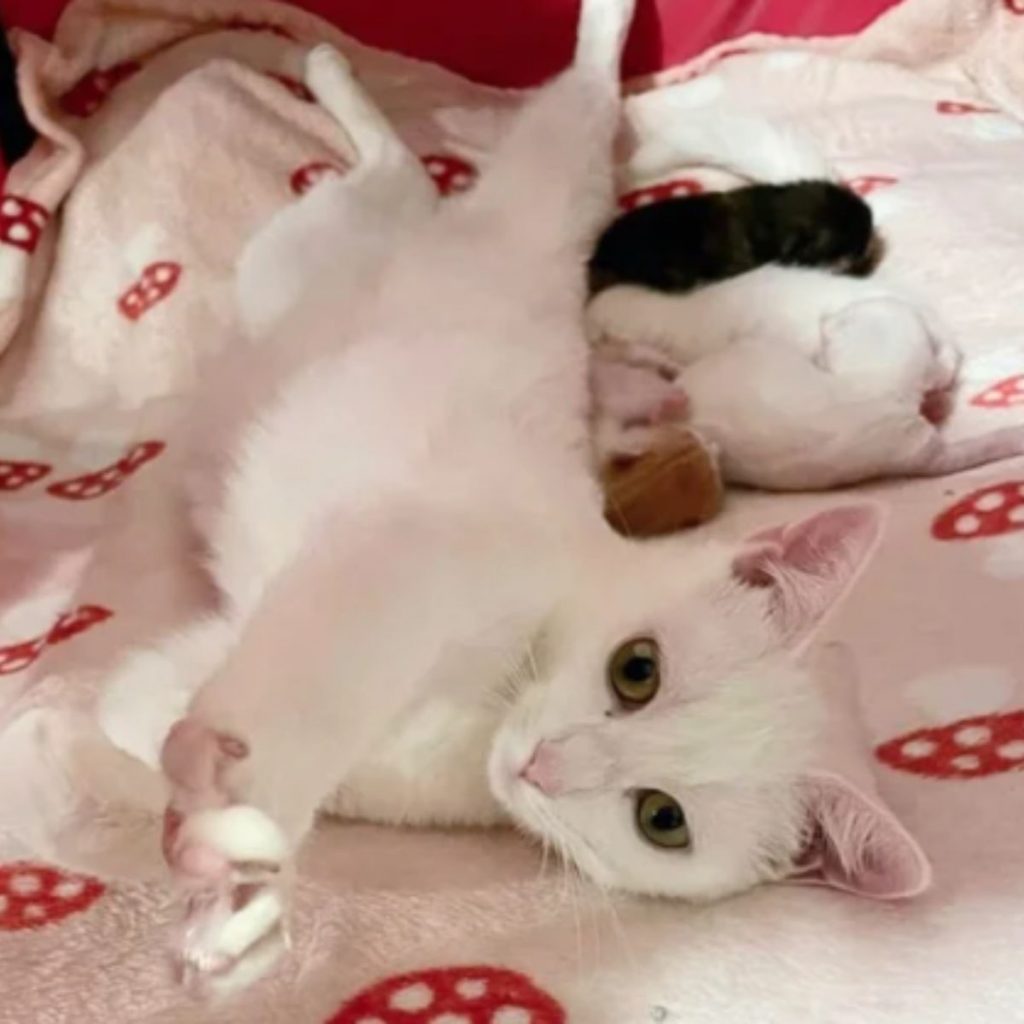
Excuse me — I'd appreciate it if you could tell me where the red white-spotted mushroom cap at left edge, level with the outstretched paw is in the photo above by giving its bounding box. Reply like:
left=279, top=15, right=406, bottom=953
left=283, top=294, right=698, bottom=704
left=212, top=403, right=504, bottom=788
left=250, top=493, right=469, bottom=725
left=0, top=861, right=104, bottom=932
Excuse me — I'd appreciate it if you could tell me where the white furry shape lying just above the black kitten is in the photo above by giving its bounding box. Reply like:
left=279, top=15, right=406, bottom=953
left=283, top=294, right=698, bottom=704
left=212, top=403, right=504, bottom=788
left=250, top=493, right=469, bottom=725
left=629, top=104, right=837, bottom=184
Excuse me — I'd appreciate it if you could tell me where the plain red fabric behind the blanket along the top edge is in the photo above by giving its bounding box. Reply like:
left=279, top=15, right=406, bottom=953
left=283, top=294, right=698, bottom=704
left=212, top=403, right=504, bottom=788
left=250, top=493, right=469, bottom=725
left=6, top=0, right=899, bottom=86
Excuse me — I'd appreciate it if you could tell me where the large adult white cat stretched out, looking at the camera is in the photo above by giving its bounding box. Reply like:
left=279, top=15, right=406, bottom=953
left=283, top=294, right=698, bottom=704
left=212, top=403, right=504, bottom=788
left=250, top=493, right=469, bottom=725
left=92, top=6, right=929, bottom=990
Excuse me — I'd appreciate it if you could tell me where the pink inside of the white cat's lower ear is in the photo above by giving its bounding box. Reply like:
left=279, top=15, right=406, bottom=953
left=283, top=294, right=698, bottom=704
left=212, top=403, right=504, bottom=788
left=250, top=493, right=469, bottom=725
left=794, top=772, right=932, bottom=899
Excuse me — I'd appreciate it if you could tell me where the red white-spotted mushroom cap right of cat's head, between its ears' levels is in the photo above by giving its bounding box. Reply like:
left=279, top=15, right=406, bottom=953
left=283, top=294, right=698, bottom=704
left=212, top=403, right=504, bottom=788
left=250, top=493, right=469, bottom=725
left=874, top=711, right=1024, bottom=778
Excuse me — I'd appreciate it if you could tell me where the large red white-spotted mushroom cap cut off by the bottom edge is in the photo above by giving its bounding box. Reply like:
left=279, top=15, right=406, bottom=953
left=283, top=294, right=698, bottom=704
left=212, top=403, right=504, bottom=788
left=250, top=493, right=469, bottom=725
left=327, top=967, right=565, bottom=1024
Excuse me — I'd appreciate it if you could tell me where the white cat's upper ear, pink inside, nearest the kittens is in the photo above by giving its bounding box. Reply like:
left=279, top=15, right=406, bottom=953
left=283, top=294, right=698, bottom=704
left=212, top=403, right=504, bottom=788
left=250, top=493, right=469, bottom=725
left=732, top=503, right=883, bottom=649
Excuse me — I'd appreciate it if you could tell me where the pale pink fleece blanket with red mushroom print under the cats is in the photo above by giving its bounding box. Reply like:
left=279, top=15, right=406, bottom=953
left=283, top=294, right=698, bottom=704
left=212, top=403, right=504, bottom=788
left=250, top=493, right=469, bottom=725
left=0, top=0, right=1024, bottom=1024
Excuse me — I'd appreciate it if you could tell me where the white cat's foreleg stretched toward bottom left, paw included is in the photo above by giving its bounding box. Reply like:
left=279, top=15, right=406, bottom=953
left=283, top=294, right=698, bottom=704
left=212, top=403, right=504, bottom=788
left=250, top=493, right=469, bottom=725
left=156, top=516, right=510, bottom=990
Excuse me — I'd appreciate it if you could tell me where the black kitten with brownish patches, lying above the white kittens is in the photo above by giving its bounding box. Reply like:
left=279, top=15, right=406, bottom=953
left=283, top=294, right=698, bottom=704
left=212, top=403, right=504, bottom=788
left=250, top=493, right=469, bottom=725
left=590, top=181, right=881, bottom=292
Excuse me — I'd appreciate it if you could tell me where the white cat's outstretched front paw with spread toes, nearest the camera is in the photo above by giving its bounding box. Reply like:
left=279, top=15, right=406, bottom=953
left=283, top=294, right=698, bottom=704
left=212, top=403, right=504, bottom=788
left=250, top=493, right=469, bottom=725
left=165, top=805, right=289, bottom=994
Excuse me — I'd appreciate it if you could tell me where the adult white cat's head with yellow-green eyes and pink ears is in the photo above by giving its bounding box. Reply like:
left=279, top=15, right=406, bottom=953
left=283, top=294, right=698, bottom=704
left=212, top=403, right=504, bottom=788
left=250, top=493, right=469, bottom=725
left=489, top=506, right=930, bottom=899
